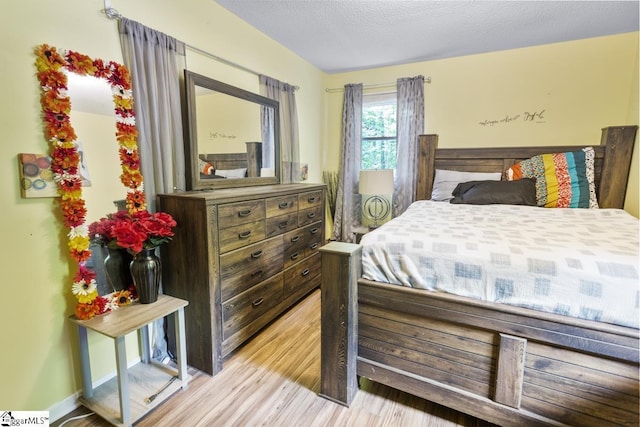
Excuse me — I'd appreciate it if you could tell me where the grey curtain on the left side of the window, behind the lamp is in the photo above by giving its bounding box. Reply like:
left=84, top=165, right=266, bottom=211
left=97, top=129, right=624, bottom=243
left=333, top=83, right=363, bottom=243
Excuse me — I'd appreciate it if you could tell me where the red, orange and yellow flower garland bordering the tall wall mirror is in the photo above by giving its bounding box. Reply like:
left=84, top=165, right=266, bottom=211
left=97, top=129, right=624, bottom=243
left=35, top=44, right=147, bottom=319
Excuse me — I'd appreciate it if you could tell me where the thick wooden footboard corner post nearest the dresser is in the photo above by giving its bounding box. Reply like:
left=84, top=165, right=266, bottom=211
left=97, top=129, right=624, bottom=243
left=320, top=242, right=362, bottom=406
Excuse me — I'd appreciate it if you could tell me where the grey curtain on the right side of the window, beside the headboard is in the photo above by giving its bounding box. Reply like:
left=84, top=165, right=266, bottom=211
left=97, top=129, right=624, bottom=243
left=393, top=76, right=424, bottom=217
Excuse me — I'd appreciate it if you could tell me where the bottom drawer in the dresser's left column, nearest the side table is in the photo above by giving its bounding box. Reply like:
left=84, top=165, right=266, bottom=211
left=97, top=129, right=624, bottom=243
left=222, top=273, right=284, bottom=339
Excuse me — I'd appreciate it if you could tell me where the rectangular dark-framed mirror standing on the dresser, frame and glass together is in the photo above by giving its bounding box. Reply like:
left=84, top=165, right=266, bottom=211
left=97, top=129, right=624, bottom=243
left=185, top=71, right=280, bottom=190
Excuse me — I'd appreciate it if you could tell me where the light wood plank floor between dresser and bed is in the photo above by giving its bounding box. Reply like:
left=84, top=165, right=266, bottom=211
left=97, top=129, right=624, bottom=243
left=52, top=290, right=492, bottom=427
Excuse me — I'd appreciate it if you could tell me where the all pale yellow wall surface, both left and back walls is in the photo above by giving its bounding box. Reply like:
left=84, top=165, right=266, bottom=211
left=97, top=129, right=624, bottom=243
left=0, top=0, right=638, bottom=418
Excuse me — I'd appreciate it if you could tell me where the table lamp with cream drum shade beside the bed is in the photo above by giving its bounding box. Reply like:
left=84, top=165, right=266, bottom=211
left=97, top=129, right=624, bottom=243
left=358, top=169, right=393, bottom=229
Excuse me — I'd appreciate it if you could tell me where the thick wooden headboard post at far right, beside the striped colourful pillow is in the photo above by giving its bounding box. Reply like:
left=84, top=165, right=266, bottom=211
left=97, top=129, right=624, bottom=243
left=598, top=126, right=638, bottom=209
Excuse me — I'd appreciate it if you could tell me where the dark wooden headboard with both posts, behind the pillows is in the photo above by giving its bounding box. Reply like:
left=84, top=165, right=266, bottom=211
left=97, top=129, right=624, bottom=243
left=416, top=126, right=638, bottom=209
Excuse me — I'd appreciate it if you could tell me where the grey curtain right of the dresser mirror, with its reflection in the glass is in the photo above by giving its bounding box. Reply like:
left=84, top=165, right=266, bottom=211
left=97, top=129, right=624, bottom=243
left=260, top=75, right=300, bottom=184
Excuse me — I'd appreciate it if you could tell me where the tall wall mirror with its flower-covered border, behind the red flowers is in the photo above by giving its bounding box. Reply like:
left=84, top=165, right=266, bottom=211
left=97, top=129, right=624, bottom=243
left=35, top=44, right=146, bottom=319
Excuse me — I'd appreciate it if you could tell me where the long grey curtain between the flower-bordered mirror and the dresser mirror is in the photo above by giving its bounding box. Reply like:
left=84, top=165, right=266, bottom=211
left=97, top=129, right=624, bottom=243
left=119, top=17, right=185, bottom=360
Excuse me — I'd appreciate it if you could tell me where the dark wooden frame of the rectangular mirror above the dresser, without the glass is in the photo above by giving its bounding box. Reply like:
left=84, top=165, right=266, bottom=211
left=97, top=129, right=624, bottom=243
left=184, top=70, right=281, bottom=190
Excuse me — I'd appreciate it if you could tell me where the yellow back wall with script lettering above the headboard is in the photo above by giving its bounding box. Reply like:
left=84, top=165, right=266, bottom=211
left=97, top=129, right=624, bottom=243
left=325, top=32, right=638, bottom=216
